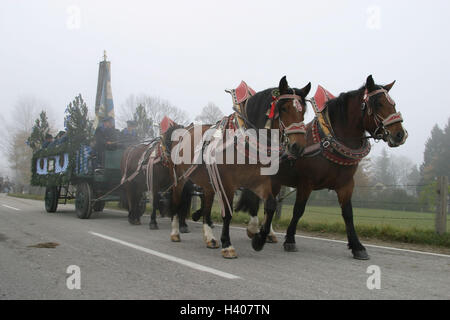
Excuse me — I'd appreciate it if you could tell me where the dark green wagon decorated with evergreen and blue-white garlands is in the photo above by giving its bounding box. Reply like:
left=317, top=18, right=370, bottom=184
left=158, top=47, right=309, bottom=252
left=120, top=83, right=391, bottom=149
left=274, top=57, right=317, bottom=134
left=31, top=143, right=130, bottom=219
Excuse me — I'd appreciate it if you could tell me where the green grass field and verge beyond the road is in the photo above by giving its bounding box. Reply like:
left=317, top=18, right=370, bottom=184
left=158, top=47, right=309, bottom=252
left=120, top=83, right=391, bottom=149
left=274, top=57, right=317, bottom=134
left=10, top=194, right=450, bottom=248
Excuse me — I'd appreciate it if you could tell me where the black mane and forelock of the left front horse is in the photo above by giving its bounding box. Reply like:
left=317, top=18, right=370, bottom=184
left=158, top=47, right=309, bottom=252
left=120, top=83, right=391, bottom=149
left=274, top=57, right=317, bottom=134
left=245, top=88, right=305, bottom=129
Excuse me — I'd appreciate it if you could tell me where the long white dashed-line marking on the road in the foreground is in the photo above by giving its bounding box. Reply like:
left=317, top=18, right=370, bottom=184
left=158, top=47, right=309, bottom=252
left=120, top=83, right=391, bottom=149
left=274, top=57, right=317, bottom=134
left=89, top=231, right=241, bottom=279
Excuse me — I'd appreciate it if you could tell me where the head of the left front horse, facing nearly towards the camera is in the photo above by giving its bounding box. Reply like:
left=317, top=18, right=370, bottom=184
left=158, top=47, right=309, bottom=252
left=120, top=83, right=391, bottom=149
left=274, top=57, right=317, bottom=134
left=269, top=77, right=311, bottom=157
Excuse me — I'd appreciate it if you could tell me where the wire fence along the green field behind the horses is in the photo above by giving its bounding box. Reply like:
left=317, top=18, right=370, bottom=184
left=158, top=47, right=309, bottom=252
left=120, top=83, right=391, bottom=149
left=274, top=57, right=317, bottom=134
left=272, top=184, right=450, bottom=230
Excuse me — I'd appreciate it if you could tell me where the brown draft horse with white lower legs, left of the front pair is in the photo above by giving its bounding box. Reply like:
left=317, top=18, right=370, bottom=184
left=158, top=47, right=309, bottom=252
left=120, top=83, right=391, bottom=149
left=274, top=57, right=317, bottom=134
left=163, top=77, right=311, bottom=259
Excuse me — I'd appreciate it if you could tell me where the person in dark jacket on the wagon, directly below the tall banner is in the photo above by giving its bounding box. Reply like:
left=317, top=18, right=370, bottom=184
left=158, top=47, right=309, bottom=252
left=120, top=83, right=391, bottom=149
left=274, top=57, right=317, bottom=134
left=94, top=117, right=117, bottom=168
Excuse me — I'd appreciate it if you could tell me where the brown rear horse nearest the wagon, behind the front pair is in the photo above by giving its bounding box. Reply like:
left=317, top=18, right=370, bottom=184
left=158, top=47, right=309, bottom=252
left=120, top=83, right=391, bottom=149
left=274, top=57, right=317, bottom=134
left=121, top=139, right=194, bottom=233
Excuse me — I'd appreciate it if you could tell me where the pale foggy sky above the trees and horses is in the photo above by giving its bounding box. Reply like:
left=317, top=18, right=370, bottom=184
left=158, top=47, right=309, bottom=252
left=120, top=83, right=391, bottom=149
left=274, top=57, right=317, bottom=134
left=0, top=0, right=450, bottom=172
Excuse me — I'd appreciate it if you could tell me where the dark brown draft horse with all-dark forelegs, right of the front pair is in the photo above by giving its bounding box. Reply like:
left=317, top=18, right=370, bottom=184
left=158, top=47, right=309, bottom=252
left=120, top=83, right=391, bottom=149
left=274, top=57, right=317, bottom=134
left=236, top=76, right=408, bottom=260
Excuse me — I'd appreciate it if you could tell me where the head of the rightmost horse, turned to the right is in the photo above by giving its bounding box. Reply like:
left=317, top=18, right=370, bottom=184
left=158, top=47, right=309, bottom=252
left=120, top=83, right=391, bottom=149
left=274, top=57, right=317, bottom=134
left=362, top=75, right=408, bottom=147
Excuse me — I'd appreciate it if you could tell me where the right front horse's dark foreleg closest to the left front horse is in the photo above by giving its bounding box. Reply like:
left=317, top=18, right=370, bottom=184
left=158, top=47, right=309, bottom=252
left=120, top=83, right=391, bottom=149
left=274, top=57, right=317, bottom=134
left=283, top=186, right=312, bottom=252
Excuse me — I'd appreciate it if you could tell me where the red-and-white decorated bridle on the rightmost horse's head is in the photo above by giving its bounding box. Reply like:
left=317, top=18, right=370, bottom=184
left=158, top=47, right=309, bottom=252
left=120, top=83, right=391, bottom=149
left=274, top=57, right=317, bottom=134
left=361, top=88, right=408, bottom=141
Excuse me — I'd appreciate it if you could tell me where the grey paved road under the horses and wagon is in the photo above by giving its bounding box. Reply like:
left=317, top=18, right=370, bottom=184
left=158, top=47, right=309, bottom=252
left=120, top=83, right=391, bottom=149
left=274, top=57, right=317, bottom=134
left=0, top=195, right=450, bottom=300
